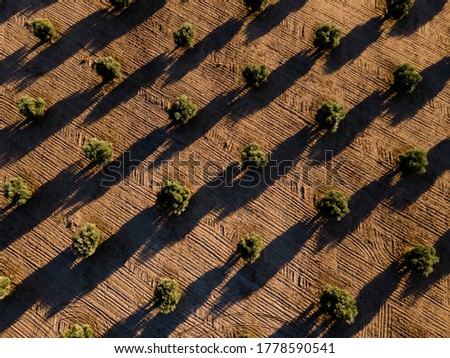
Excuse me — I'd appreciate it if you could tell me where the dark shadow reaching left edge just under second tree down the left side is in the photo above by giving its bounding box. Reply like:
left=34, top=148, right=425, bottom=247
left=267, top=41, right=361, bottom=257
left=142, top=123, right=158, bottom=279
left=0, top=84, right=101, bottom=166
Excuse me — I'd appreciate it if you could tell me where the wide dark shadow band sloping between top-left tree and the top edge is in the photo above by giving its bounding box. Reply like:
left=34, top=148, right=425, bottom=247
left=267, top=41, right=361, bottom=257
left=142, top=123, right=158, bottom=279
left=17, top=0, right=166, bottom=89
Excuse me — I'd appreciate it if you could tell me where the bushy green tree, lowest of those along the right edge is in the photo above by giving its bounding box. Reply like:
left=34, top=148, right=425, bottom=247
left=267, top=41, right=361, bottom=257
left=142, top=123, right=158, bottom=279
left=403, top=245, right=439, bottom=277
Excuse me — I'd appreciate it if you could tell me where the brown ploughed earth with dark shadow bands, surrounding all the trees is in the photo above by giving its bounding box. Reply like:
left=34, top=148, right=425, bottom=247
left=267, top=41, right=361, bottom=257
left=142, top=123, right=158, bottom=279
left=0, top=0, right=450, bottom=337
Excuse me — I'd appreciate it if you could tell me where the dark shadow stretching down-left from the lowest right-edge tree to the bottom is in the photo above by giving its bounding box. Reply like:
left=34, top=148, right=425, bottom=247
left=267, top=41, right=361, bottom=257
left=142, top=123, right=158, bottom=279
left=324, top=262, right=402, bottom=338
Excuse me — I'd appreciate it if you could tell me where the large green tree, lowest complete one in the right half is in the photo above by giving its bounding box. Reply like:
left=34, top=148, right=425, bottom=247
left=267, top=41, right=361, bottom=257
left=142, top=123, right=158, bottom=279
left=320, top=285, right=358, bottom=324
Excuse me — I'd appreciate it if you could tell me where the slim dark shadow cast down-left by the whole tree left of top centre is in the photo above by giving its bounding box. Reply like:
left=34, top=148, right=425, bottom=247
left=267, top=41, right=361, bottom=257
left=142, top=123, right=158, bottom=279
left=85, top=54, right=170, bottom=124
